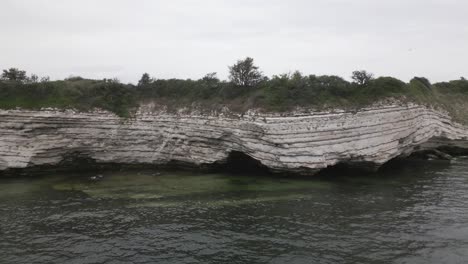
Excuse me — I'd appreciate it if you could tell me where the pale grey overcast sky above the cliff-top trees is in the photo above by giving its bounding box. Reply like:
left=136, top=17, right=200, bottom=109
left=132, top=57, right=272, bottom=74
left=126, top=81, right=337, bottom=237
left=0, top=0, right=468, bottom=83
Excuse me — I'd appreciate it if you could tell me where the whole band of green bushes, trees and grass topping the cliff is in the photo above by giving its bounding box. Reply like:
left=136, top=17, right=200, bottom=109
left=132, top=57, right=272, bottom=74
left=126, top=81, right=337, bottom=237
left=0, top=58, right=468, bottom=121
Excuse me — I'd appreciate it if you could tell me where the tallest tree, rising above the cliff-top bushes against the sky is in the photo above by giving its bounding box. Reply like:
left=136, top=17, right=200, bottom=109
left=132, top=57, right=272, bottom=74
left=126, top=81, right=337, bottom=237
left=229, top=57, right=263, bottom=87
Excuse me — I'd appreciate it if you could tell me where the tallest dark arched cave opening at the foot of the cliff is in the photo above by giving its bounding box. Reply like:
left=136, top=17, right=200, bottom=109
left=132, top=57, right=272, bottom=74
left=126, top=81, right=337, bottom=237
left=218, top=151, right=271, bottom=174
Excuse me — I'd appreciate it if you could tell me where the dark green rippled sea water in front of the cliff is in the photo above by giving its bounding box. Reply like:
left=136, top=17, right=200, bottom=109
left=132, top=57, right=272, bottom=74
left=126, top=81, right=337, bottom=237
left=0, top=159, right=468, bottom=263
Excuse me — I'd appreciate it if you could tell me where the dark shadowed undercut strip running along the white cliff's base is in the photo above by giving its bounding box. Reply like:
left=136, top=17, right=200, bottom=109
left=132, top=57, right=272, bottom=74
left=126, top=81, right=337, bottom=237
left=0, top=147, right=468, bottom=178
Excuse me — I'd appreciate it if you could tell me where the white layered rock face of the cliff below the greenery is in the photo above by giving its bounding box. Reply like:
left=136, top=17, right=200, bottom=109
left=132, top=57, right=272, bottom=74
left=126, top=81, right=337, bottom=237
left=0, top=104, right=468, bottom=174
